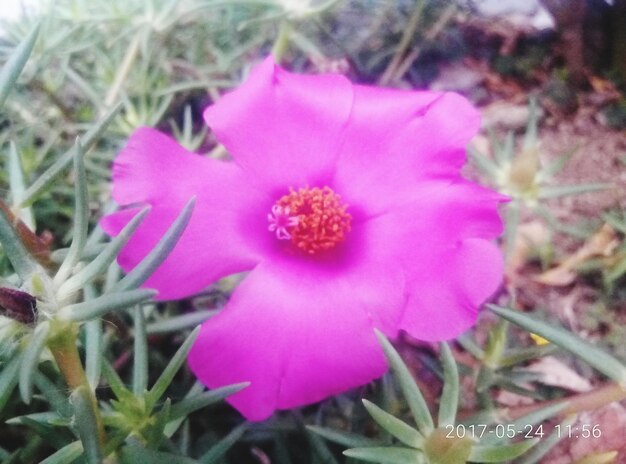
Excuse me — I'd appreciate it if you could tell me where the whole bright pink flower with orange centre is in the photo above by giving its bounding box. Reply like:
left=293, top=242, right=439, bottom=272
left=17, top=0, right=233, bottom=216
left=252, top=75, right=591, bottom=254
left=102, top=58, right=505, bottom=420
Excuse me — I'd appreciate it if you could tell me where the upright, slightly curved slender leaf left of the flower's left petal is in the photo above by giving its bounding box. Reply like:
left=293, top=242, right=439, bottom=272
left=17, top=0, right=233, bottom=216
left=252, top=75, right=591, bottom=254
left=54, top=137, right=89, bottom=286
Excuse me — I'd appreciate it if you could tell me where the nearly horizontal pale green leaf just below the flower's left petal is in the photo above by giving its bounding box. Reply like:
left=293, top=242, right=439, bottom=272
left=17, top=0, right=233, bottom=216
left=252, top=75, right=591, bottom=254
left=58, top=288, right=158, bottom=322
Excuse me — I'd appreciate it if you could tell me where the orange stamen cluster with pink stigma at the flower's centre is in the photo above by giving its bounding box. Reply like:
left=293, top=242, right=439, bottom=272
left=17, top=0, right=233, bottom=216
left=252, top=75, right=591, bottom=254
left=267, top=187, right=352, bottom=255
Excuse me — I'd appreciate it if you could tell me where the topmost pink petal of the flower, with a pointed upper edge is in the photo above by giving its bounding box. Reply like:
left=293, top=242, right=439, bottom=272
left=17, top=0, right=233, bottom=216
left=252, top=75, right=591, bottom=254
left=204, top=57, right=352, bottom=196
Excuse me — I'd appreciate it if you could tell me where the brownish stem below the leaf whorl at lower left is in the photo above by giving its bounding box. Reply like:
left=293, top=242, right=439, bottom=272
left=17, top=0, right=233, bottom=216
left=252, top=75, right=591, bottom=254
left=48, top=324, right=106, bottom=446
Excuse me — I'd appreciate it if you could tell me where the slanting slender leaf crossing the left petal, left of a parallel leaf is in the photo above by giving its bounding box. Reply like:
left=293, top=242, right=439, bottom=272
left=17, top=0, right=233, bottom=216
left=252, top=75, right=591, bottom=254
left=58, top=207, right=150, bottom=299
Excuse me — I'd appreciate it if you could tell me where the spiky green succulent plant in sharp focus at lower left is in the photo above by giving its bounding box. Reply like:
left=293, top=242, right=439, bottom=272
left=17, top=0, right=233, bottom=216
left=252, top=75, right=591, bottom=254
left=0, top=29, right=246, bottom=464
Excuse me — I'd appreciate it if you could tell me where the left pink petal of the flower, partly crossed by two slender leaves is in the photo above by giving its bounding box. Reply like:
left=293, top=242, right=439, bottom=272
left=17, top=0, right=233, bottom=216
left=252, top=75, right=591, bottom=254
left=101, top=128, right=272, bottom=300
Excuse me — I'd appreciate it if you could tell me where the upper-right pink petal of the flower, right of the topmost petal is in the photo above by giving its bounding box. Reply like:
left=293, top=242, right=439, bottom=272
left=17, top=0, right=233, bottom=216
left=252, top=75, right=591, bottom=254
left=334, top=86, right=480, bottom=215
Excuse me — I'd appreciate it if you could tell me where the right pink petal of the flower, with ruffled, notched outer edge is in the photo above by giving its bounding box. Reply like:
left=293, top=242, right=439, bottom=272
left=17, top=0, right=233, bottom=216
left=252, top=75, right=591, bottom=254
left=360, top=181, right=504, bottom=340
